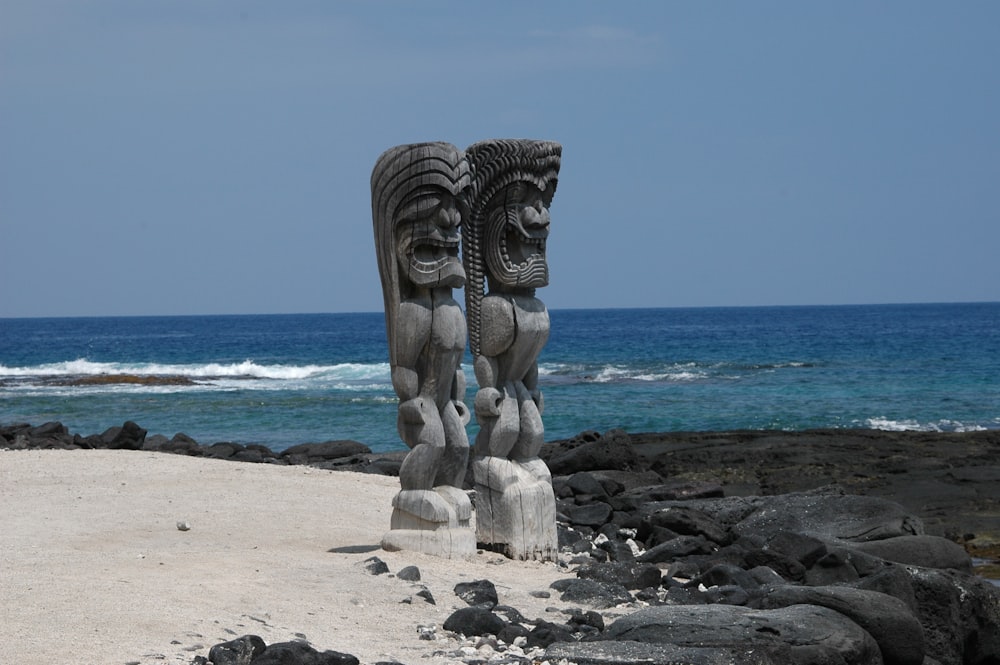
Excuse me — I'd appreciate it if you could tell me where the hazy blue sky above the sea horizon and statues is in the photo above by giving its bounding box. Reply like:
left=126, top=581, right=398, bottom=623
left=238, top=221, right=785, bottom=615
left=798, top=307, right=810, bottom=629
left=0, top=0, right=1000, bottom=317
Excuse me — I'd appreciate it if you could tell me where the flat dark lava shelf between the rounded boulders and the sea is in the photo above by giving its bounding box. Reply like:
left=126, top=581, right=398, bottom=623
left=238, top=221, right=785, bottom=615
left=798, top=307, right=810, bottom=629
left=543, top=429, right=1000, bottom=540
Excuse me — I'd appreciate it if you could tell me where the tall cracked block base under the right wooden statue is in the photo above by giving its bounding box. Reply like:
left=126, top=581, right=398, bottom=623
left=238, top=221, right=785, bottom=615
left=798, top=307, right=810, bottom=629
left=472, top=457, right=559, bottom=561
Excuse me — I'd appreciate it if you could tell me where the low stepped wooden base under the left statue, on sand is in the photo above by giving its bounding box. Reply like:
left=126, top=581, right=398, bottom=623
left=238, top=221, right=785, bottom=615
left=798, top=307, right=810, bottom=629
left=382, top=486, right=476, bottom=559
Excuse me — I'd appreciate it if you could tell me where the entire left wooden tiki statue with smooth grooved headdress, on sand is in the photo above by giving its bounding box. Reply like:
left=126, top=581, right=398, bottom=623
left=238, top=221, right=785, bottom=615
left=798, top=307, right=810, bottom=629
left=371, top=143, right=476, bottom=558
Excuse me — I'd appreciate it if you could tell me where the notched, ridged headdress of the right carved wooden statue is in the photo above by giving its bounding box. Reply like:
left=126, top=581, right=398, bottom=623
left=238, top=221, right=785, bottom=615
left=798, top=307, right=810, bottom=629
left=462, top=139, right=562, bottom=357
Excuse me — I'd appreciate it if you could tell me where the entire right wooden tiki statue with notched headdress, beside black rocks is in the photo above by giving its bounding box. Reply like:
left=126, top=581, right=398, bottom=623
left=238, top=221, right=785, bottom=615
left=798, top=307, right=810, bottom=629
left=462, top=140, right=562, bottom=560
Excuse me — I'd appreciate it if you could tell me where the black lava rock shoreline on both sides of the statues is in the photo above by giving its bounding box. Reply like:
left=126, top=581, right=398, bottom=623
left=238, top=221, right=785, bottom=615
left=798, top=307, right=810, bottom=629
left=0, top=423, right=1000, bottom=665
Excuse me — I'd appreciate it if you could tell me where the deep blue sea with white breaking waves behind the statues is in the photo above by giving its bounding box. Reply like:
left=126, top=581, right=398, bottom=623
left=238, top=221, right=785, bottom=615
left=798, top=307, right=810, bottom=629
left=0, top=303, right=1000, bottom=451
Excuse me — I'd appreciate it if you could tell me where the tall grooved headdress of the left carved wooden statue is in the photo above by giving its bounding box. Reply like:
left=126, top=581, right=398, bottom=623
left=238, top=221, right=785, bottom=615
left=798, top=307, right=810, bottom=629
left=371, top=142, right=469, bottom=365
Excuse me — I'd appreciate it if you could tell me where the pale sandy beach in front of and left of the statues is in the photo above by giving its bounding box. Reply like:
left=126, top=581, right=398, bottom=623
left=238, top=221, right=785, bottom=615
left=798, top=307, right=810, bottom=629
left=0, top=450, right=570, bottom=665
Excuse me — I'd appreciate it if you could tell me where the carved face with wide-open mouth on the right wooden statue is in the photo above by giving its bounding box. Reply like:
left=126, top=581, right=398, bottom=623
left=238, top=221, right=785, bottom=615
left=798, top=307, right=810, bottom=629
left=483, top=181, right=549, bottom=288
